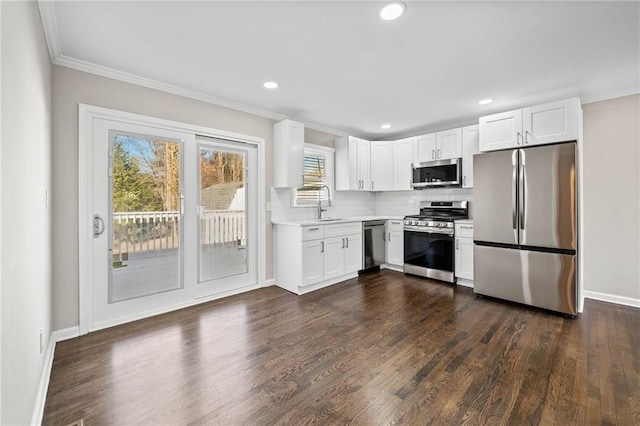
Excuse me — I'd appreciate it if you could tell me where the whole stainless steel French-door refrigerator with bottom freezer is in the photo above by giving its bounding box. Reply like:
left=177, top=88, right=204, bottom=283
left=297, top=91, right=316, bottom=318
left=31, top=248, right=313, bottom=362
left=473, top=142, right=578, bottom=316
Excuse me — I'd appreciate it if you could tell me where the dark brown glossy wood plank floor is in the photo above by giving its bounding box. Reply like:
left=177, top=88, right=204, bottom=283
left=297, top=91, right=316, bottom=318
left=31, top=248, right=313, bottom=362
left=44, top=271, right=640, bottom=425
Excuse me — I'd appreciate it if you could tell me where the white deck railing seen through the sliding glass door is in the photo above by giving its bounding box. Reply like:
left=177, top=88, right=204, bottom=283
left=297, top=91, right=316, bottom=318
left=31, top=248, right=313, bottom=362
left=113, top=210, right=246, bottom=259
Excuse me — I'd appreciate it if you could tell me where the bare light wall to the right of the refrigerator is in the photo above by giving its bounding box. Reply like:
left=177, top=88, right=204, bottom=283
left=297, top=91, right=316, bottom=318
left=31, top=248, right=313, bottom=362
left=582, top=95, right=640, bottom=306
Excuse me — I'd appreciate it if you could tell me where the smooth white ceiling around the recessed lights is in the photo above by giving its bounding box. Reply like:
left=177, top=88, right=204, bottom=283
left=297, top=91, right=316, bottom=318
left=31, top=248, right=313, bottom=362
left=40, top=1, right=640, bottom=140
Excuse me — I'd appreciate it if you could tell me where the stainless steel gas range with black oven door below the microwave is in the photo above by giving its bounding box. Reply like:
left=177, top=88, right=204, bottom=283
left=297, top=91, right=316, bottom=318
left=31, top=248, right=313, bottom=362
left=404, top=201, right=469, bottom=283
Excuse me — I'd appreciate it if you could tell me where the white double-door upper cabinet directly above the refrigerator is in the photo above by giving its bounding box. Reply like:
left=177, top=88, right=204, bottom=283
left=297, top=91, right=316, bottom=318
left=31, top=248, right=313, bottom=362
left=480, top=98, right=580, bottom=151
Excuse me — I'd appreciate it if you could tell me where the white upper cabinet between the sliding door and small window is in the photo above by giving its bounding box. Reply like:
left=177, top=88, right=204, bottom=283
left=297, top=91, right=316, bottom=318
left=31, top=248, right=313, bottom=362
left=273, top=120, right=304, bottom=188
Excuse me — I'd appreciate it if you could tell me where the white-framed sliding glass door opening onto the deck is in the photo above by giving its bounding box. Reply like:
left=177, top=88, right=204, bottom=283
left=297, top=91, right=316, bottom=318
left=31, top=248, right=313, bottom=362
left=88, top=119, right=258, bottom=330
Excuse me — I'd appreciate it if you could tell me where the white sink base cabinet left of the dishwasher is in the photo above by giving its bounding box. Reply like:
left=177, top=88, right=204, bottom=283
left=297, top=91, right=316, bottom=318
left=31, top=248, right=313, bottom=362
left=275, top=222, right=362, bottom=294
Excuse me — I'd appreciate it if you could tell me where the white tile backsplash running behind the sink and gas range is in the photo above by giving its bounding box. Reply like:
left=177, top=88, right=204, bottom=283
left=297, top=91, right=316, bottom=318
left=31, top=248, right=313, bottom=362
left=271, top=188, right=473, bottom=220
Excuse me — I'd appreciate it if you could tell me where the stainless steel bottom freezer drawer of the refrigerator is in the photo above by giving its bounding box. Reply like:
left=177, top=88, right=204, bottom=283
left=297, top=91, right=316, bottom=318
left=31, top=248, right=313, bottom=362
left=473, top=244, right=577, bottom=315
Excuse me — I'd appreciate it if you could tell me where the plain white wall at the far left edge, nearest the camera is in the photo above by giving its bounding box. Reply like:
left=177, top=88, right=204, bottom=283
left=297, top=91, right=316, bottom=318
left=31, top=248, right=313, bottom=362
left=0, top=2, right=51, bottom=424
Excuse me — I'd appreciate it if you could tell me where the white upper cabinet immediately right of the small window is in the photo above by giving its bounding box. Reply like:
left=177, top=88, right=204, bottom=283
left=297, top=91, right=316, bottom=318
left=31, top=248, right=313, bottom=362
left=335, top=136, right=371, bottom=191
